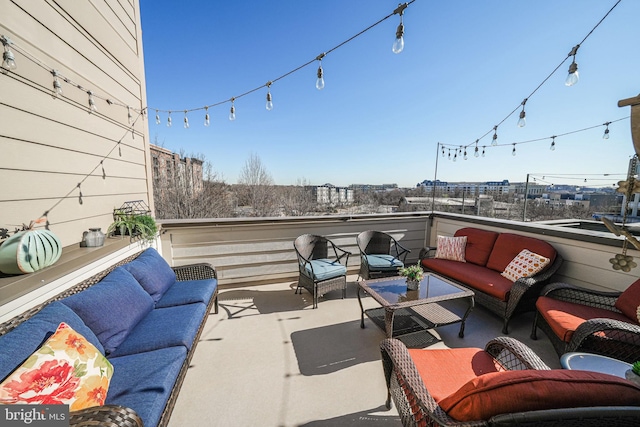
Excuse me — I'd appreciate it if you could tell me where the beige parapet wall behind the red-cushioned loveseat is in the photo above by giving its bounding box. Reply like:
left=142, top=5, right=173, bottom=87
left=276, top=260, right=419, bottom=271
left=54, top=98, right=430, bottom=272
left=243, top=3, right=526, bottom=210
left=429, top=215, right=640, bottom=291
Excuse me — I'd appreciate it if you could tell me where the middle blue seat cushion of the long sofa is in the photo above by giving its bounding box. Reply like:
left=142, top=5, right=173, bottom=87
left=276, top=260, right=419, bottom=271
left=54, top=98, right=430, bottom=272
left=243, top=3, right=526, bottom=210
left=111, top=303, right=207, bottom=357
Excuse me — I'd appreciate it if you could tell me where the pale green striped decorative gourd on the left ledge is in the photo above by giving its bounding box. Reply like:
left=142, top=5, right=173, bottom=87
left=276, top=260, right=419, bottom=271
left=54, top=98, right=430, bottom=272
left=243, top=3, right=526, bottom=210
left=0, top=230, right=62, bottom=274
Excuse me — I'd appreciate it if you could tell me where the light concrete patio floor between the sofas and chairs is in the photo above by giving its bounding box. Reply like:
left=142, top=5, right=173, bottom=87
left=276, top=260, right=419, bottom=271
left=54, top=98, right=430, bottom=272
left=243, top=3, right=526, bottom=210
left=169, top=276, right=559, bottom=427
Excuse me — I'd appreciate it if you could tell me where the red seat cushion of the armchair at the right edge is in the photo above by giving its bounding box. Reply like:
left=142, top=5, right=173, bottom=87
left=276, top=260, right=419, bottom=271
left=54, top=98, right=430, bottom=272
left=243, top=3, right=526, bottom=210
left=536, top=296, right=629, bottom=342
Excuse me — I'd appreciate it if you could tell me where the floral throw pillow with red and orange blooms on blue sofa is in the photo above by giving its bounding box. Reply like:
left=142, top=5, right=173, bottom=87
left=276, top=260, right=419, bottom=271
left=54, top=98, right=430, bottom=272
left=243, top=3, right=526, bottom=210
left=0, top=323, right=113, bottom=411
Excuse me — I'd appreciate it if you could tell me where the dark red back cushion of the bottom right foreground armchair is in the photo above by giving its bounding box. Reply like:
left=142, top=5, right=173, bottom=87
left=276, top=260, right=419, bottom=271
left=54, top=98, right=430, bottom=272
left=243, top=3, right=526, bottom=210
left=439, top=369, right=640, bottom=421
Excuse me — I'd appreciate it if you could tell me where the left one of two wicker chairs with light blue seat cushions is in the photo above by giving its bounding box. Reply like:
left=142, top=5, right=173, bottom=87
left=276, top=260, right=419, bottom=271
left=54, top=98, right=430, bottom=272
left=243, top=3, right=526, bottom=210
left=293, top=234, right=351, bottom=308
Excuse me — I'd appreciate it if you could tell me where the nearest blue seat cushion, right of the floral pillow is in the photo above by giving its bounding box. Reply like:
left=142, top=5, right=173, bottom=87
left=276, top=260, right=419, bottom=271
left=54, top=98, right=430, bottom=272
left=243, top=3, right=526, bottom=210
left=105, top=346, right=187, bottom=427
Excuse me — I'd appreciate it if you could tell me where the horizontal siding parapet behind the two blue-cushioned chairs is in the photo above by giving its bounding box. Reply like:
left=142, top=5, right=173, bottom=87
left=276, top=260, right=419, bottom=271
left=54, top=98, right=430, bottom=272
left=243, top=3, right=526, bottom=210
left=161, top=214, right=428, bottom=285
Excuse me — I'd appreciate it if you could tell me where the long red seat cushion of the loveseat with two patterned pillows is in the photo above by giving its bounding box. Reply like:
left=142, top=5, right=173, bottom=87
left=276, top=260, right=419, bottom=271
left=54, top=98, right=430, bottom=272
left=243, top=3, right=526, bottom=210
left=422, top=258, right=513, bottom=301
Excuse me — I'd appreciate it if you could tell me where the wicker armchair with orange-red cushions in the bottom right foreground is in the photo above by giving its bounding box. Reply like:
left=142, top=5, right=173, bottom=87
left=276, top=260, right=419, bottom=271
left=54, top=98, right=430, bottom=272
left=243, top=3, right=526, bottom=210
left=380, top=337, right=640, bottom=427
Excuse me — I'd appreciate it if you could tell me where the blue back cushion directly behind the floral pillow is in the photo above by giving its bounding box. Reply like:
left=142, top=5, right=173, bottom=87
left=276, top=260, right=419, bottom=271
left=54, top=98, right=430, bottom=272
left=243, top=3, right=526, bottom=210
left=0, top=301, right=104, bottom=380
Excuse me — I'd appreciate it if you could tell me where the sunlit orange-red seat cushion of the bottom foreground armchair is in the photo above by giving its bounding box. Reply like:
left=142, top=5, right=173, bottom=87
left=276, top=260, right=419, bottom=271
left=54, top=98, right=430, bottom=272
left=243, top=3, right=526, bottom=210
left=408, top=348, right=497, bottom=402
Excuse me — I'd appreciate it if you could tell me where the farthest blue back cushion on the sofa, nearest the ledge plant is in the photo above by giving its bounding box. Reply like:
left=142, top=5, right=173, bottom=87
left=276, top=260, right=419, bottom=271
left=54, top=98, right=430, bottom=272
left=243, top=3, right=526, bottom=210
left=123, top=248, right=176, bottom=302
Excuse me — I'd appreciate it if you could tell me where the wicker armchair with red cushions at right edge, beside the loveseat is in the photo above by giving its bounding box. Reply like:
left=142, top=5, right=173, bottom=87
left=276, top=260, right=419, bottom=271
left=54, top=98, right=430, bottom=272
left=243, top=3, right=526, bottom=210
left=531, top=283, right=640, bottom=363
